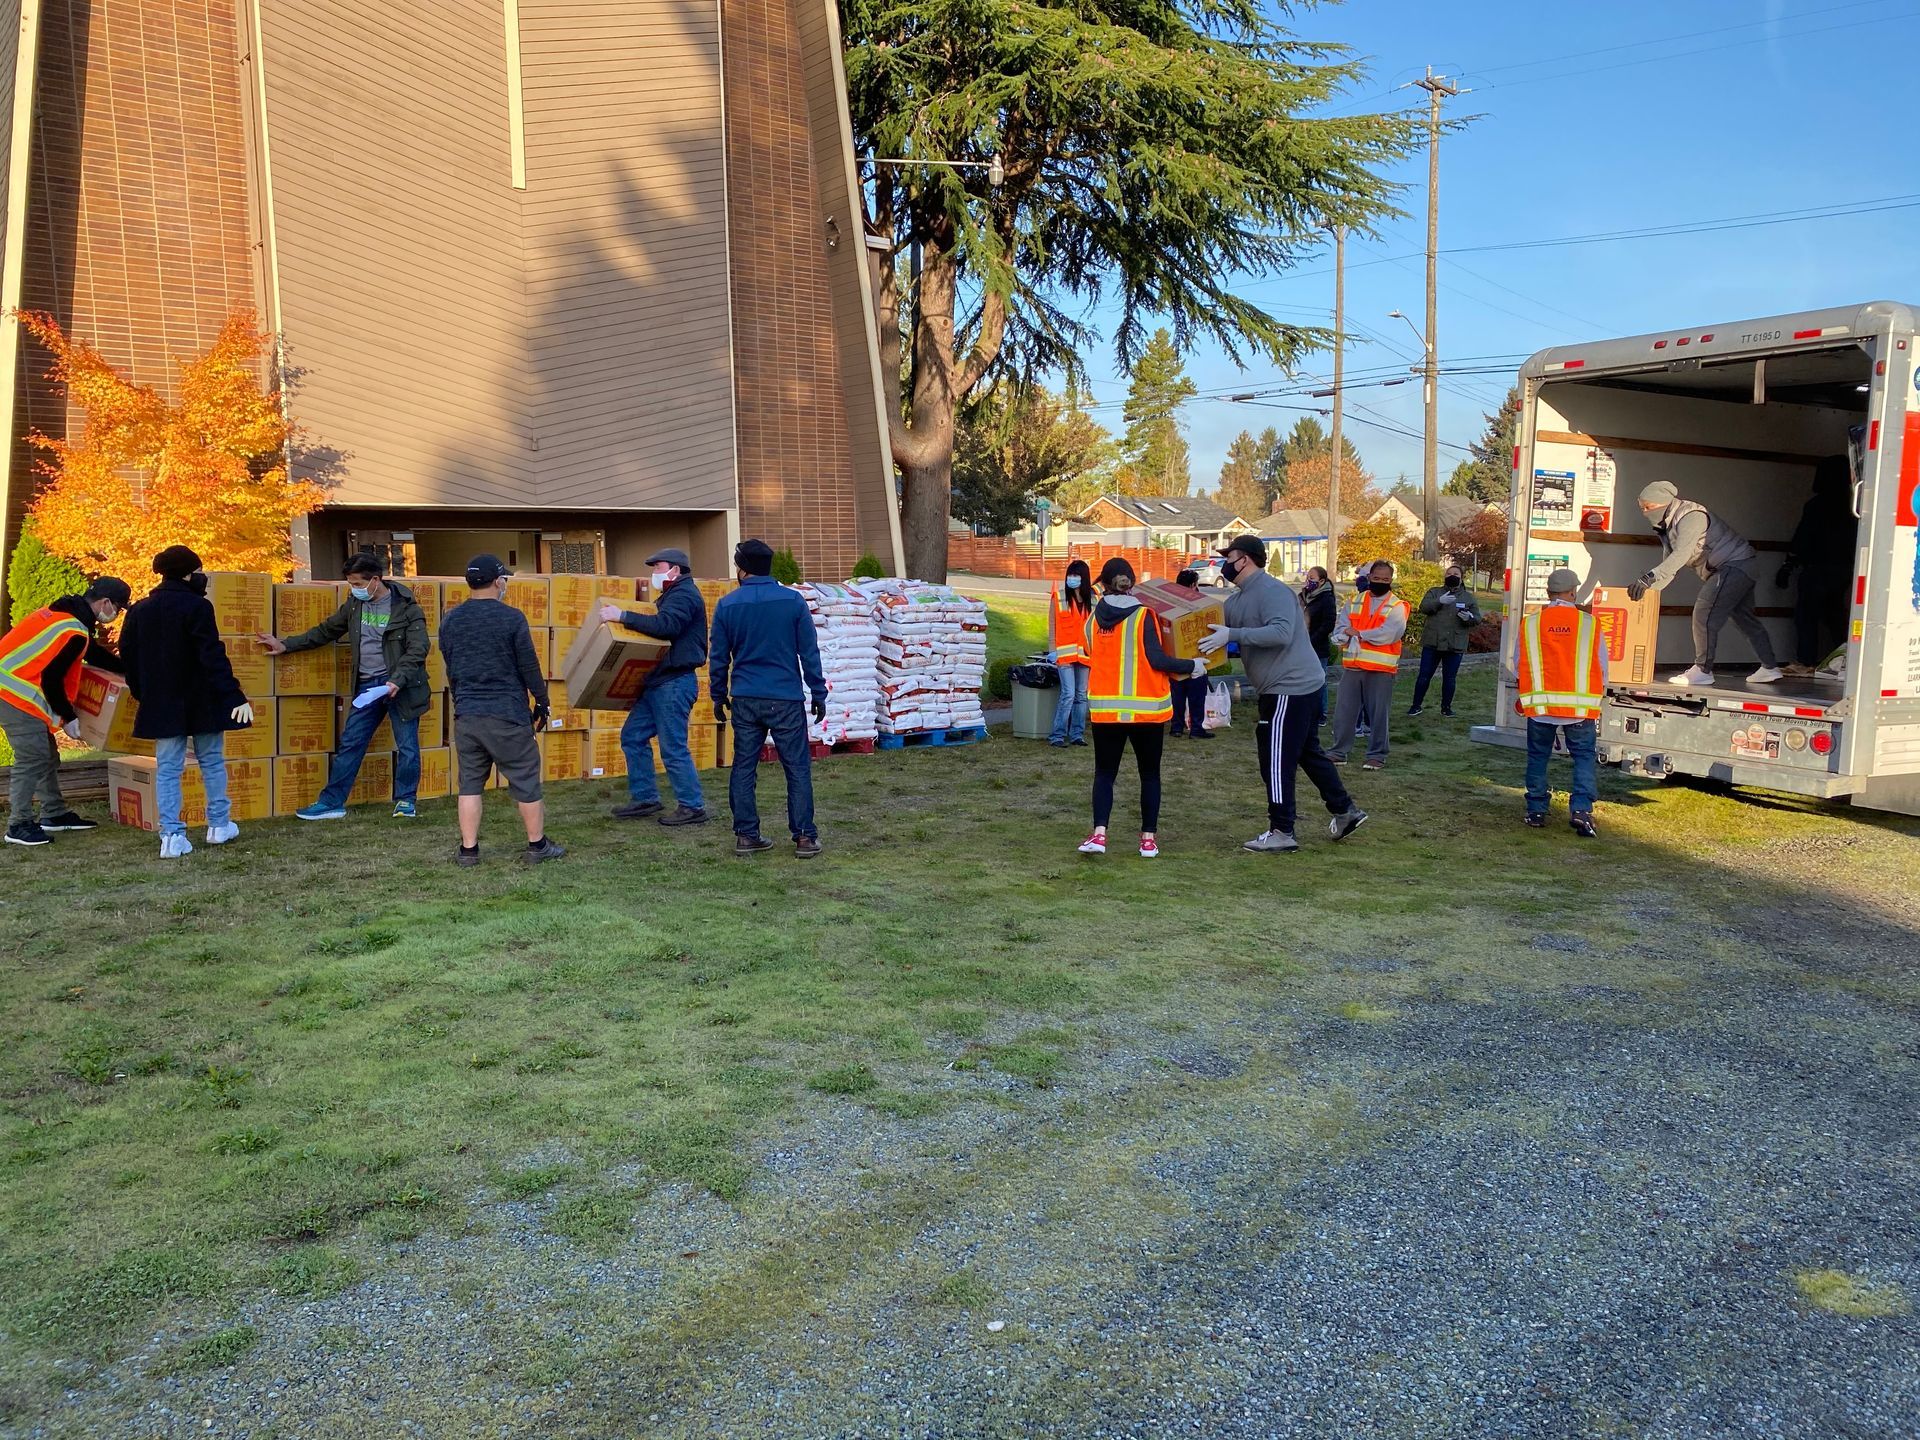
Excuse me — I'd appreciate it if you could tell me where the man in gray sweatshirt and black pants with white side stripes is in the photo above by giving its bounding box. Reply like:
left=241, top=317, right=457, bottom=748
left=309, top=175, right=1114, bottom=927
left=1200, top=536, right=1367, bottom=852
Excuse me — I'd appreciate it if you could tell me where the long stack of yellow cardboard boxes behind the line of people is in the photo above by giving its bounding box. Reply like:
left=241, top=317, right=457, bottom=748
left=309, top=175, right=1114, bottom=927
left=97, top=572, right=733, bottom=829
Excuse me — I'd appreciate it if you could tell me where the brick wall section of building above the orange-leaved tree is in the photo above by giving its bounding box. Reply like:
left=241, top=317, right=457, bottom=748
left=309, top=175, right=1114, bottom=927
left=6, top=0, right=257, bottom=540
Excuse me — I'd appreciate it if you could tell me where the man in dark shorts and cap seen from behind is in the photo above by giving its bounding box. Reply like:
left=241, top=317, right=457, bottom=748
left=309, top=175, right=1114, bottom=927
left=440, top=555, right=566, bottom=866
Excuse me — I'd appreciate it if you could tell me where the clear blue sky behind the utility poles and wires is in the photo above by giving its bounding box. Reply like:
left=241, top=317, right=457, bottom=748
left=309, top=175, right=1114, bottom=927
left=1089, top=0, right=1920, bottom=490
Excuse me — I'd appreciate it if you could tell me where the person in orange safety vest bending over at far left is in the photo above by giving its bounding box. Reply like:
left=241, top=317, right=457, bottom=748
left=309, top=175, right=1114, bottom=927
left=0, top=576, right=132, bottom=845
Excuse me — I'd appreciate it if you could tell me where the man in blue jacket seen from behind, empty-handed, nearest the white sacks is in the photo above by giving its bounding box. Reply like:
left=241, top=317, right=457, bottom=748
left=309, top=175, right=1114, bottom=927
left=707, top=540, right=828, bottom=860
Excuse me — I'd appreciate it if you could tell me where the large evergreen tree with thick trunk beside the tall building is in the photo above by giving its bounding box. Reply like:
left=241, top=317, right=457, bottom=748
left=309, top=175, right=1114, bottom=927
left=841, top=0, right=1413, bottom=578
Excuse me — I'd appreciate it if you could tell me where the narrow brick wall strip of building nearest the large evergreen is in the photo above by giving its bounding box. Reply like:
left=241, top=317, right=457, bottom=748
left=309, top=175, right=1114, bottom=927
left=720, top=0, right=866, bottom=580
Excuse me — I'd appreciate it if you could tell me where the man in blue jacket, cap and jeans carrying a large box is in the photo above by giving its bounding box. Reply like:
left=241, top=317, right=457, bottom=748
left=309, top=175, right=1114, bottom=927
left=599, top=549, right=707, bottom=826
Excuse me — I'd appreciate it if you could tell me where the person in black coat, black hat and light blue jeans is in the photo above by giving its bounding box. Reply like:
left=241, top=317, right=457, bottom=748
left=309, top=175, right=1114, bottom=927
left=121, top=545, right=253, bottom=860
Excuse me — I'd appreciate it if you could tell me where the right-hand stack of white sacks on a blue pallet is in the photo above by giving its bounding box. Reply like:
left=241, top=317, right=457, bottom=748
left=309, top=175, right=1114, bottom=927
left=852, top=580, right=987, bottom=735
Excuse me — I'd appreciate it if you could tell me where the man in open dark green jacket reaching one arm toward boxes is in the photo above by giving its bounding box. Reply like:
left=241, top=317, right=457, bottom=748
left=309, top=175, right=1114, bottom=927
left=257, top=551, right=434, bottom=820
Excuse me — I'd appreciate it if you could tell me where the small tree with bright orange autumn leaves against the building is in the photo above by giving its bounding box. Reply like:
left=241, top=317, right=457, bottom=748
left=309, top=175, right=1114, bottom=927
left=19, top=311, right=326, bottom=593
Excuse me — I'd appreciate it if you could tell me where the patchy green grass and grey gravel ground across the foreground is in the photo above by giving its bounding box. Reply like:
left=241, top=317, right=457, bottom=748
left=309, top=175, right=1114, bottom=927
left=0, top=672, right=1920, bottom=1436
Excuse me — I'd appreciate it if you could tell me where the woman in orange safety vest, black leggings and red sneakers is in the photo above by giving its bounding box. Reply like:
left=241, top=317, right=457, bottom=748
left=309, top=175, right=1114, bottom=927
left=1079, top=555, right=1206, bottom=860
